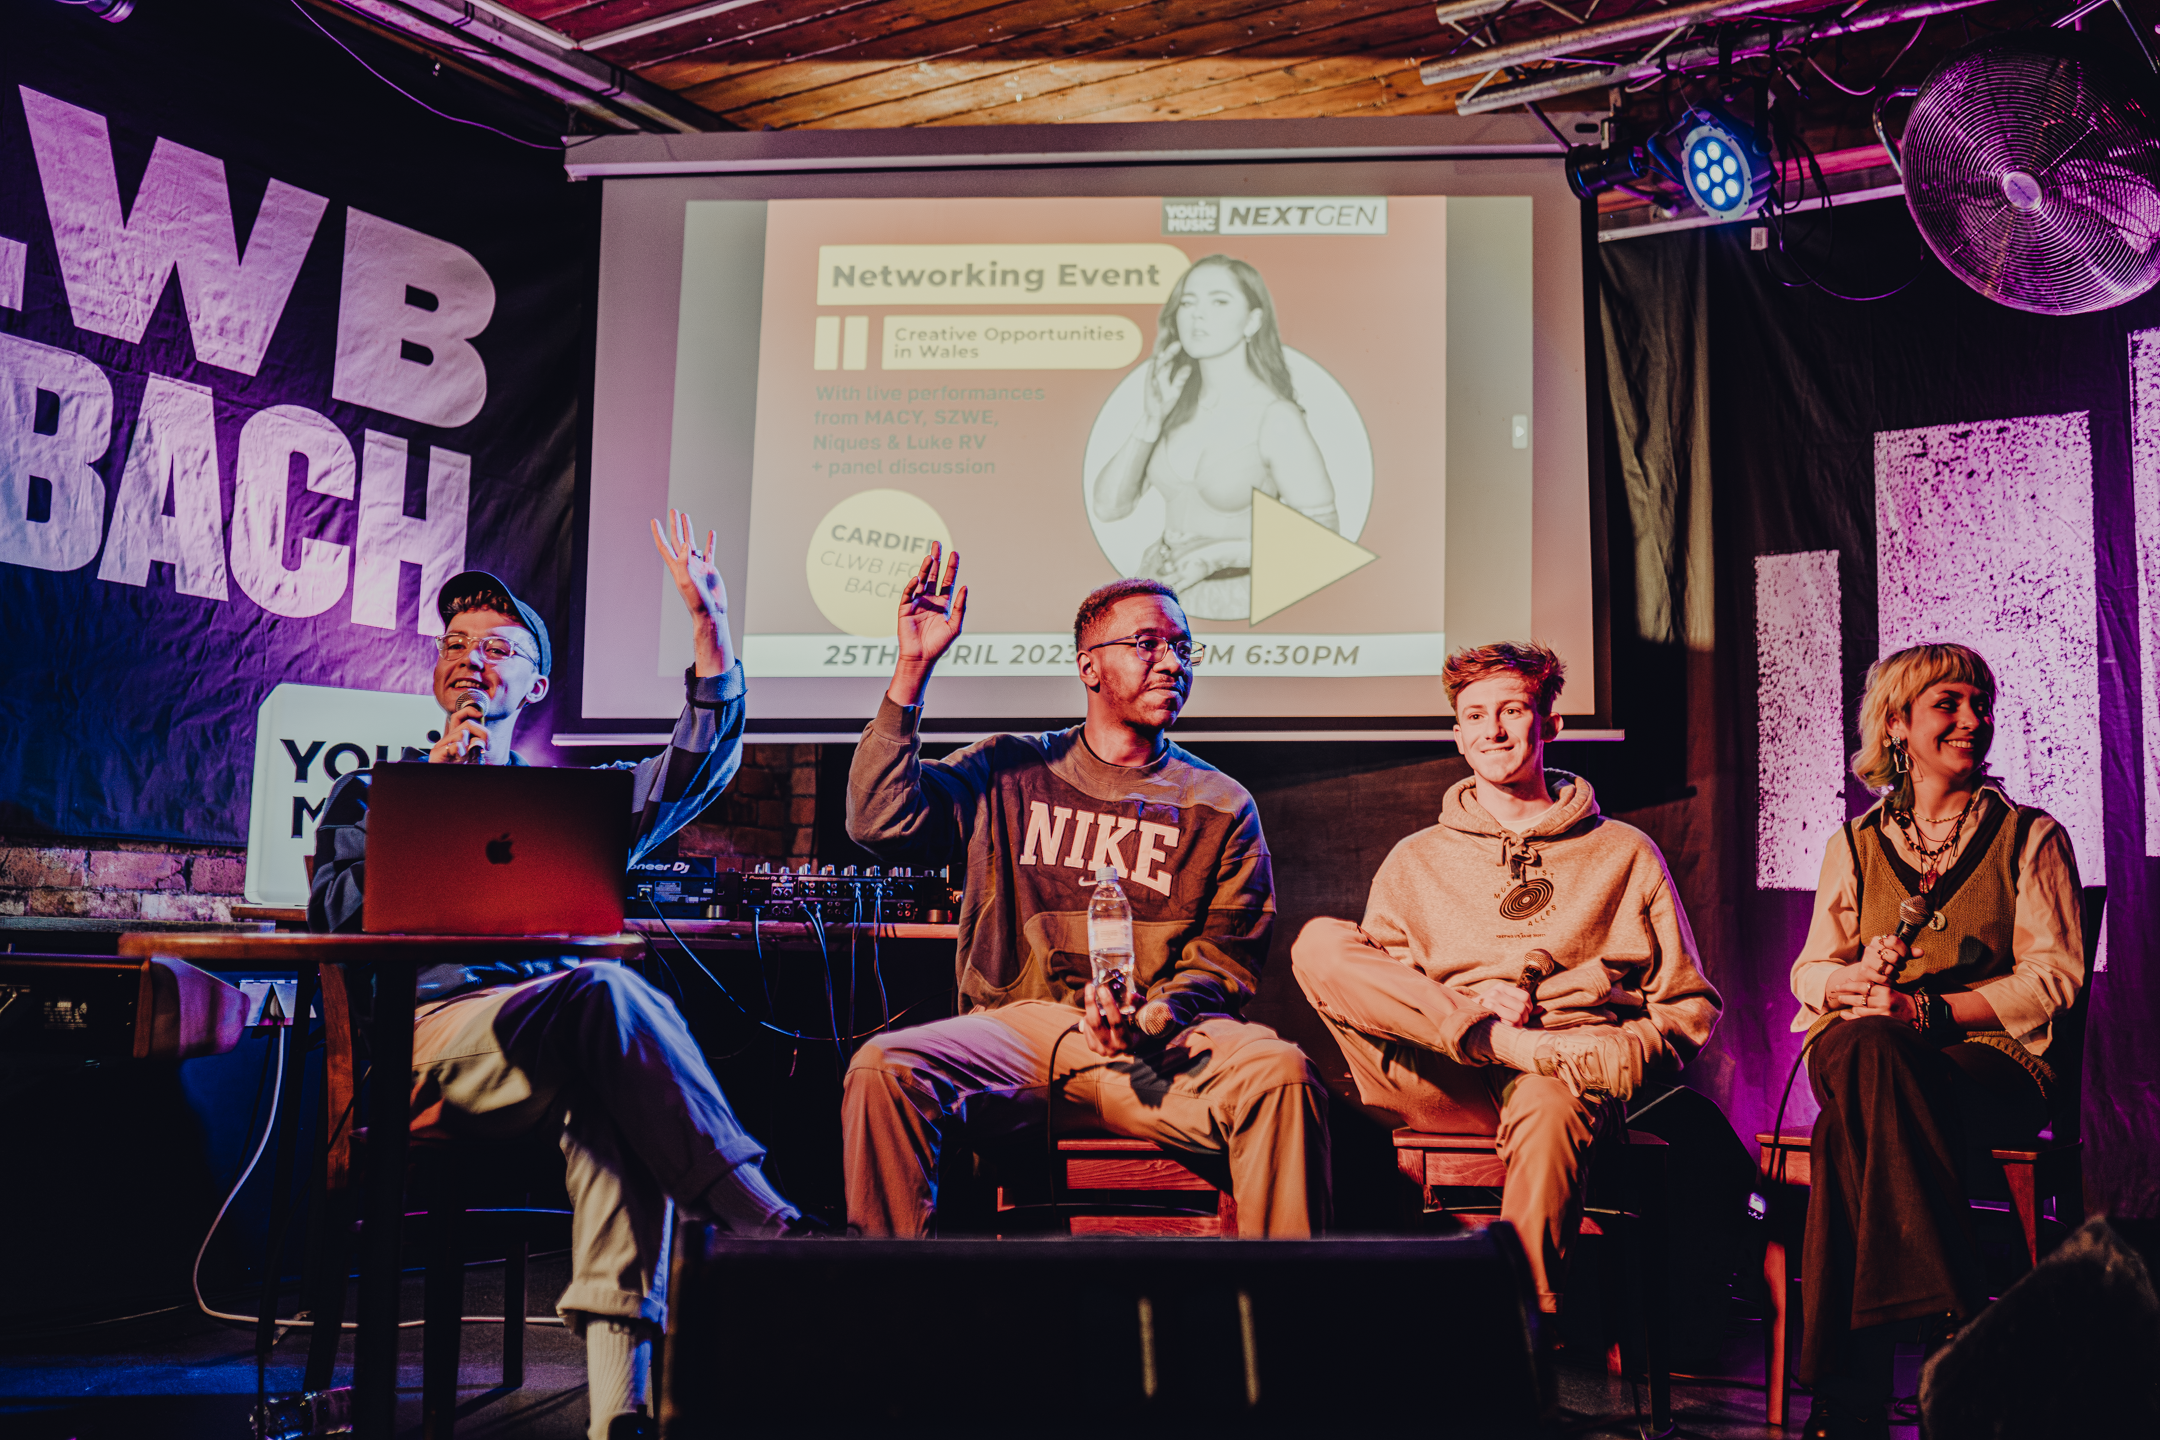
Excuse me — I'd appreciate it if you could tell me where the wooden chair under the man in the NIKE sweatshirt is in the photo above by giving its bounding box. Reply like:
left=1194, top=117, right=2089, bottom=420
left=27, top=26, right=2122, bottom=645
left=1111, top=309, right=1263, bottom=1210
left=996, top=1131, right=1238, bottom=1239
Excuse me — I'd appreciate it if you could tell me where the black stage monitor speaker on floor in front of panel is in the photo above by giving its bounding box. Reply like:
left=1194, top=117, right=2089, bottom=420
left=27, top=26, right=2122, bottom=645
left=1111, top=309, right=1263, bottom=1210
left=661, top=1224, right=1551, bottom=1440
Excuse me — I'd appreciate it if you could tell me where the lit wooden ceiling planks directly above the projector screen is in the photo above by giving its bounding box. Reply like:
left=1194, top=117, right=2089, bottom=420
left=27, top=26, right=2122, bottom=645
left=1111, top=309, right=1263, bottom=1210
left=496, top=0, right=1467, bottom=130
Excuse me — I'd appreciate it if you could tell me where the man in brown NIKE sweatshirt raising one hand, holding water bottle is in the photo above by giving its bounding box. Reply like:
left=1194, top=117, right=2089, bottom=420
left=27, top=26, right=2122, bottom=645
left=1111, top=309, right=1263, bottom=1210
left=840, top=544, right=1328, bottom=1237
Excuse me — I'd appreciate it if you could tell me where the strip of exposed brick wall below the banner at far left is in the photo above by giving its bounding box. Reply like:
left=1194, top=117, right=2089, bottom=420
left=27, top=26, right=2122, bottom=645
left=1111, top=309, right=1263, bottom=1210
left=0, top=836, right=248, bottom=920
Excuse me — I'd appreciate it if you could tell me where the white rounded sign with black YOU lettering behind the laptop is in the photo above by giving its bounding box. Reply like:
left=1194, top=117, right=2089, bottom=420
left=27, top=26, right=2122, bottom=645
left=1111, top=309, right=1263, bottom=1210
left=246, top=684, right=443, bottom=905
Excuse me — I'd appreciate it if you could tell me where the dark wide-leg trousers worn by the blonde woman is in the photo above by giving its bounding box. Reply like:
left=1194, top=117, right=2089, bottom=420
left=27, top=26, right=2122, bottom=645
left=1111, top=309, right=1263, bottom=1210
left=1795, top=1015, right=2048, bottom=1384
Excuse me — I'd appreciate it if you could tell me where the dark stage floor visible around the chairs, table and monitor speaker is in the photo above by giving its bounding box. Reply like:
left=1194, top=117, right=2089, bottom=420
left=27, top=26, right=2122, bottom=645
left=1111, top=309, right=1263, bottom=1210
left=0, top=1254, right=1918, bottom=1440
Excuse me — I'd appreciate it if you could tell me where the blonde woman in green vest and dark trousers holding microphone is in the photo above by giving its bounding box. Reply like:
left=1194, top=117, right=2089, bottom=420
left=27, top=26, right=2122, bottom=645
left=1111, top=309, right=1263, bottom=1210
left=1793, top=646, right=2084, bottom=1440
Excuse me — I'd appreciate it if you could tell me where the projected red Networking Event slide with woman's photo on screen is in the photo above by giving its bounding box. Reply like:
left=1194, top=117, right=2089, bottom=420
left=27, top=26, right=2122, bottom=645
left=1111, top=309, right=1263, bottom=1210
left=743, top=196, right=1449, bottom=678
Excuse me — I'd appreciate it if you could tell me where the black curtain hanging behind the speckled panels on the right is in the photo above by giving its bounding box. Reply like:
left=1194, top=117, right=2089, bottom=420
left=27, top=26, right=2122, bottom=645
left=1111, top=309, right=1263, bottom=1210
left=1601, top=199, right=2160, bottom=1215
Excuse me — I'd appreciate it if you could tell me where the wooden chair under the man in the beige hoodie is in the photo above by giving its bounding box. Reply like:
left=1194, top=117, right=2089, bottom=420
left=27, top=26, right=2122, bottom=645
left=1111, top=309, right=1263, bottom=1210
left=1395, top=1127, right=1672, bottom=1434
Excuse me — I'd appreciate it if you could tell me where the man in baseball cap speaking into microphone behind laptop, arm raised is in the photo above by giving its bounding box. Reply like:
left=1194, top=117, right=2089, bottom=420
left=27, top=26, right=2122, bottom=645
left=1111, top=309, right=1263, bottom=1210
left=307, top=512, right=823, bottom=1440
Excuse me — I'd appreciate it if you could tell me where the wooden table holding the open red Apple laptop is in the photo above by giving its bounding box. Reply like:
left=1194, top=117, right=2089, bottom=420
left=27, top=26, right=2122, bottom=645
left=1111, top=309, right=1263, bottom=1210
left=119, top=930, right=646, bottom=1438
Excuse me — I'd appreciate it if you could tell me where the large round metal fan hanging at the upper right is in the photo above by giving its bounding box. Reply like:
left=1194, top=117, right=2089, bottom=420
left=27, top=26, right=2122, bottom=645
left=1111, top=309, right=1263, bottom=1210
left=1877, top=30, right=2160, bottom=315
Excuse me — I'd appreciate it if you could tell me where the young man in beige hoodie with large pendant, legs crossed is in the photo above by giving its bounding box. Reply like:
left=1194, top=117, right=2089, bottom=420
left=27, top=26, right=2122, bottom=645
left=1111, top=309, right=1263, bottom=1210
left=1292, top=643, right=1719, bottom=1313
